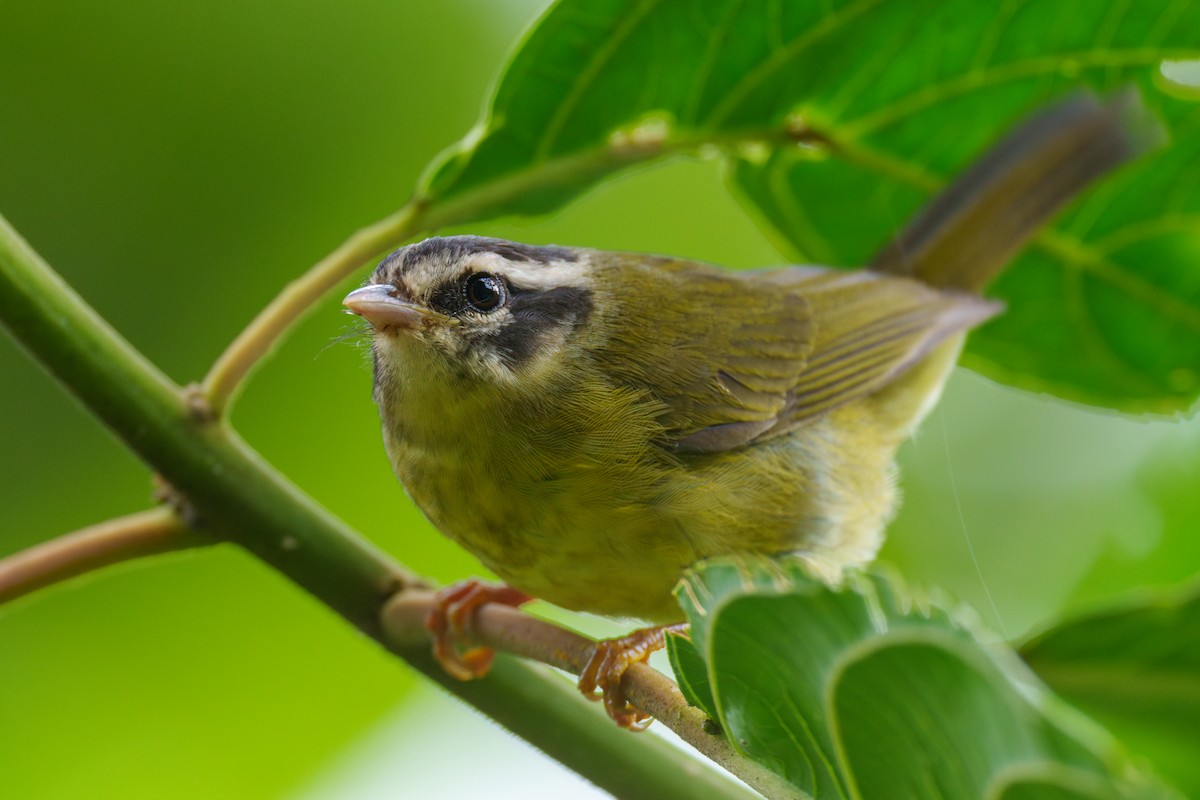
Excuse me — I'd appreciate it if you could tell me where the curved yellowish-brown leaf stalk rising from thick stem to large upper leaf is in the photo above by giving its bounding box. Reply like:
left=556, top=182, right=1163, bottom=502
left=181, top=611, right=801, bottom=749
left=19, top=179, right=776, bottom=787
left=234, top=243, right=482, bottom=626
left=203, top=201, right=421, bottom=415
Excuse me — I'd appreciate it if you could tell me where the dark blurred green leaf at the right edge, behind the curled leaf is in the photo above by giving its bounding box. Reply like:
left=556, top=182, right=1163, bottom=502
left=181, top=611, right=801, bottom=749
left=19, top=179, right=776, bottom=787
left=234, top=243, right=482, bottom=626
left=1021, top=590, right=1200, bottom=796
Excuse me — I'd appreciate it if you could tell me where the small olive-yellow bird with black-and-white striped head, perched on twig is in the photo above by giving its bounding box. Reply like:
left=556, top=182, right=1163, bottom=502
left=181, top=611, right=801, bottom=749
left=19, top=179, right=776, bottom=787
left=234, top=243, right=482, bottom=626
left=344, top=94, right=1144, bottom=727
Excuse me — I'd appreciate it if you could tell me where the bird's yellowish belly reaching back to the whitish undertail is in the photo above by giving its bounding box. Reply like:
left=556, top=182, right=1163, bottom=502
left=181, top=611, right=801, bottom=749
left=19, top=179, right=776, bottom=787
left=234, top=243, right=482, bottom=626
left=385, top=341, right=959, bottom=622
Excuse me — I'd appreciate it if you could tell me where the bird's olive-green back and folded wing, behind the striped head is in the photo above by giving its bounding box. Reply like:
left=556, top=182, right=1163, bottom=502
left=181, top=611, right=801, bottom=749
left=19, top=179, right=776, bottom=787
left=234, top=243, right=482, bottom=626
left=595, top=257, right=1000, bottom=453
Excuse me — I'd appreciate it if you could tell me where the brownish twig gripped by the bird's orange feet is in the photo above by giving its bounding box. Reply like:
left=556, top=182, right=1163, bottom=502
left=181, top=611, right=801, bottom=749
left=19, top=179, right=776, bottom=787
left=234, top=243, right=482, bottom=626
left=382, top=589, right=805, bottom=798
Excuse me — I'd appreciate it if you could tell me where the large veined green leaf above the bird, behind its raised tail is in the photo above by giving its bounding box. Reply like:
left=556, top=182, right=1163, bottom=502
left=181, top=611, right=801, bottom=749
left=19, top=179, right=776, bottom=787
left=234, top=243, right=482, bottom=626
left=421, top=0, right=1200, bottom=411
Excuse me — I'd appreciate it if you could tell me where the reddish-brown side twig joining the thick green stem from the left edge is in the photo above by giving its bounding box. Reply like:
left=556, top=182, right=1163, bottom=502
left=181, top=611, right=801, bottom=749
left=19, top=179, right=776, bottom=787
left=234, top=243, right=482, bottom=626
left=0, top=509, right=202, bottom=603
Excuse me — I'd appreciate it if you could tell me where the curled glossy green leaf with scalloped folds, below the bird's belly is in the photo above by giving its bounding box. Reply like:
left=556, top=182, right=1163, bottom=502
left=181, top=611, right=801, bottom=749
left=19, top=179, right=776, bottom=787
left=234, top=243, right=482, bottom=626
left=676, top=558, right=1172, bottom=800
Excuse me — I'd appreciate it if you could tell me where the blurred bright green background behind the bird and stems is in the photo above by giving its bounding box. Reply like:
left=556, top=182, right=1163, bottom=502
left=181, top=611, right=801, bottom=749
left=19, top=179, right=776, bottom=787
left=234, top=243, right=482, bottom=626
left=0, top=0, right=1200, bottom=799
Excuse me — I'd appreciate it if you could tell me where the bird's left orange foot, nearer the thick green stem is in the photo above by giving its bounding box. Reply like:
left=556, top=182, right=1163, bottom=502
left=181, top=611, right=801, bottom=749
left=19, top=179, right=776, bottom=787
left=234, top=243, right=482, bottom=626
left=425, top=578, right=533, bottom=680
